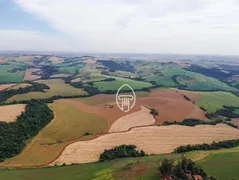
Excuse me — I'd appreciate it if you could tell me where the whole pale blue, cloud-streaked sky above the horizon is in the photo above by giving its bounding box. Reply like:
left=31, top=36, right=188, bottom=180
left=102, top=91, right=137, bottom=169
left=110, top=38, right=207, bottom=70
left=0, top=0, right=239, bottom=55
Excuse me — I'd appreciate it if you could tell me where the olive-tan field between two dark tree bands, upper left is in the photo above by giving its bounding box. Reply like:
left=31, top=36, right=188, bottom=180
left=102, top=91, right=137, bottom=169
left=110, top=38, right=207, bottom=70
left=8, top=79, right=86, bottom=102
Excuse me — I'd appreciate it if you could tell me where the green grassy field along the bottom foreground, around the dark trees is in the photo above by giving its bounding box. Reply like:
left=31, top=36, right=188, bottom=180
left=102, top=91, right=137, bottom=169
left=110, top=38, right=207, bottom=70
left=0, top=147, right=239, bottom=180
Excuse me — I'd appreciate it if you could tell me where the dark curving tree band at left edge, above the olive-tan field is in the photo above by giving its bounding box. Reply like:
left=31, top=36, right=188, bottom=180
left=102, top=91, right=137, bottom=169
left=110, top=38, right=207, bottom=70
left=0, top=81, right=50, bottom=102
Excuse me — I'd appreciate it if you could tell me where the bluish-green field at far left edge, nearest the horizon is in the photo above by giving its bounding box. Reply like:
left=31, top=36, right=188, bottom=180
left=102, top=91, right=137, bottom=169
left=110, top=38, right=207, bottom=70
left=0, top=63, right=25, bottom=83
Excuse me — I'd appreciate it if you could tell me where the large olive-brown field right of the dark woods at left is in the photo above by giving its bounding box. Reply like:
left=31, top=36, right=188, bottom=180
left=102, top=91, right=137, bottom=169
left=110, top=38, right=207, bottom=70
left=0, top=101, right=107, bottom=167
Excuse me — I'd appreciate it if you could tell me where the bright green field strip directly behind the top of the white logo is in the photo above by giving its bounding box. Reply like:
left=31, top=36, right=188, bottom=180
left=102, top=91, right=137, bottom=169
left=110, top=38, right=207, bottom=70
left=86, top=76, right=152, bottom=92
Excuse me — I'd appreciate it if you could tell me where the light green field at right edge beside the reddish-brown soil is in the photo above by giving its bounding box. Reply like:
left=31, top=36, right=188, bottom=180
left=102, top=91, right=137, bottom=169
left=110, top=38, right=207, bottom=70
left=196, top=92, right=239, bottom=113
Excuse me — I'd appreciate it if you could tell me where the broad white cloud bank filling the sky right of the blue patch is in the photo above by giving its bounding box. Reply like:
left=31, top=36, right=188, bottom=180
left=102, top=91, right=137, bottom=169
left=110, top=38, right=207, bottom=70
left=6, top=0, right=239, bottom=54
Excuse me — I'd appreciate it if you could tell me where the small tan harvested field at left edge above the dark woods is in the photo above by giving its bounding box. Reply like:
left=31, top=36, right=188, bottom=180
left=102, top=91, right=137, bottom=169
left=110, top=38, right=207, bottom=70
left=0, top=104, right=26, bottom=122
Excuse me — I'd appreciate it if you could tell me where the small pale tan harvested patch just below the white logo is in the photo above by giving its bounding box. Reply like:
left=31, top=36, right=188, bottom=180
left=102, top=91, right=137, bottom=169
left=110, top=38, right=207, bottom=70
left=109, top=106, right=155, bottom=132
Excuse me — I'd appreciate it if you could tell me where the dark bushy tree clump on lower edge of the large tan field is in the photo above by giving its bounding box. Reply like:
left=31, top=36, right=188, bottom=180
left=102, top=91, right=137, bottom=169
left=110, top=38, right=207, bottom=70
left=100, top=145, right=146, bottom=161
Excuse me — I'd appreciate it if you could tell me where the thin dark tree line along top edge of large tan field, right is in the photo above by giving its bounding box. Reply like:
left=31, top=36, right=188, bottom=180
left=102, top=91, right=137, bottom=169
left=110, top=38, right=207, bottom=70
left=163, top=118, right=237, bottom=128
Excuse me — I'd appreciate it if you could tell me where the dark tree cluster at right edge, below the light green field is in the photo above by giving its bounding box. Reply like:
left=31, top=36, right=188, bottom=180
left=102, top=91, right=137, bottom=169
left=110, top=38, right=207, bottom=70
left=206, top=106, right=239, bottom=118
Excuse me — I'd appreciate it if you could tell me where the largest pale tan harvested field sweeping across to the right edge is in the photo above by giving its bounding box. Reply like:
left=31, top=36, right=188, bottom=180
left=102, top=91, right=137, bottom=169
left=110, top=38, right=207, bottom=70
left=52, top=124, right=239, bottom=165
